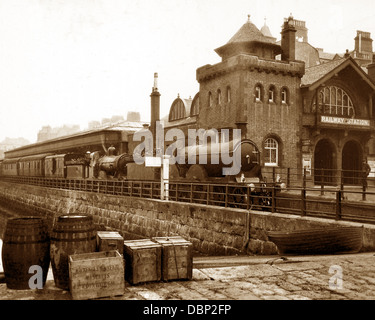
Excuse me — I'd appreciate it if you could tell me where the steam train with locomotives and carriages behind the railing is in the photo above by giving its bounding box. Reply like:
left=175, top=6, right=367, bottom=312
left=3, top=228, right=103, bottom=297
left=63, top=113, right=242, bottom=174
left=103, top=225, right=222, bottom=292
left=0, top=139, right=282, bottom=208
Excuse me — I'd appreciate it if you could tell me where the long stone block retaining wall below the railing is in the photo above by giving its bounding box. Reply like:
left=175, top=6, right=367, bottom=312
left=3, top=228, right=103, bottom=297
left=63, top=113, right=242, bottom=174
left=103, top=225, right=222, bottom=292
left=0, top=182, right=375, bottom=255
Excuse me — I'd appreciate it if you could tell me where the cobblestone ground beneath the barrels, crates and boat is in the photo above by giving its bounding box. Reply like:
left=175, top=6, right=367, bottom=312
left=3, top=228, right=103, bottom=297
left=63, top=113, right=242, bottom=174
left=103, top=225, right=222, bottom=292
left=0, top=253, right=375, bottom=300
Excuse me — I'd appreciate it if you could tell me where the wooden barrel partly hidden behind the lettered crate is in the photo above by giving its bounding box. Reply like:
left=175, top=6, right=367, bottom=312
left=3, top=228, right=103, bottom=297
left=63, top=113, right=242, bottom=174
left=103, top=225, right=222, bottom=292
left=50, top=214, right=96, bottom=290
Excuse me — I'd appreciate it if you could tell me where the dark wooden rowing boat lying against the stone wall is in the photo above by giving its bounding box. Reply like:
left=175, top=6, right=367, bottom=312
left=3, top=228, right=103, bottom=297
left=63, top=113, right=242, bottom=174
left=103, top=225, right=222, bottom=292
left=267, top=226, right=363, bottom=255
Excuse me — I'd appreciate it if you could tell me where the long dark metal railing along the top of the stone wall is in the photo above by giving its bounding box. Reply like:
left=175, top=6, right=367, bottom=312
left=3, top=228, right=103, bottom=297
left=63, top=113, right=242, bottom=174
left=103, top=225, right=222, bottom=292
left=0, top=168, right=375, bottom=224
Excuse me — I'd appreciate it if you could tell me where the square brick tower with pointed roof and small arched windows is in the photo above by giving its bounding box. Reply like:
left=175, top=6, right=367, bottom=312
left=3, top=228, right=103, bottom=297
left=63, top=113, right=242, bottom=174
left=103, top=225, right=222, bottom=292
left=197, top=13, right=305, bottom=176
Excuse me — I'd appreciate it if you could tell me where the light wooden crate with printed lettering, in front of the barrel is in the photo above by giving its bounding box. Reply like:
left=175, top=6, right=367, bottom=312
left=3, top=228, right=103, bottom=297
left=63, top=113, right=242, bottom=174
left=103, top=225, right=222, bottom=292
left=69, top=250, right=125, bottom=300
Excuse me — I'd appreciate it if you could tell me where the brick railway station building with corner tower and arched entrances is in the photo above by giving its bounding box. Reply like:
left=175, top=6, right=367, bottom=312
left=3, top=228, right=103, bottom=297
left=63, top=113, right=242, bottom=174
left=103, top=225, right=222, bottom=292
left=165, top=16, right=375, bottom=184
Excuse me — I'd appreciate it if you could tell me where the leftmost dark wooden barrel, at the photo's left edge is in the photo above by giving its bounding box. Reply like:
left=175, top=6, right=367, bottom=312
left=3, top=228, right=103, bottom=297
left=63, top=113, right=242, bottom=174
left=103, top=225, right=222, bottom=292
left=2, top=217, right=50, bottom=290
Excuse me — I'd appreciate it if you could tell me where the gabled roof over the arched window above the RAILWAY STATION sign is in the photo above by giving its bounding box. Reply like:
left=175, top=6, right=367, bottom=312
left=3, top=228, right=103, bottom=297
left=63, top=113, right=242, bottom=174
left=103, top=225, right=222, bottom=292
left=301, top=57, right=375, bottom=90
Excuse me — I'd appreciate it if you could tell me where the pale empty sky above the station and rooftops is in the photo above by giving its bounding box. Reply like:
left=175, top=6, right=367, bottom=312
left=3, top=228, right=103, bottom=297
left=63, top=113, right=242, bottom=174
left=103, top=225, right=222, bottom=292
left=0, top=0, right=375, bottom=143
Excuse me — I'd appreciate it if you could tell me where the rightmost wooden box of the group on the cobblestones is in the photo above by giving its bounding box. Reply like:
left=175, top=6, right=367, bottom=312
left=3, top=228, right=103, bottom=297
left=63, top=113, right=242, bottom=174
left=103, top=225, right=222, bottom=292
left=152, top=236, right=193, bottom=281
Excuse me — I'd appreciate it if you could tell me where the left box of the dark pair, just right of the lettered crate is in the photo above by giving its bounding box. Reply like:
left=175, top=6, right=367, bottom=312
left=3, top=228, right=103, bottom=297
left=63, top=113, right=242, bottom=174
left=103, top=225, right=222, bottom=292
left=124, top=239, right=161, bottom=284
